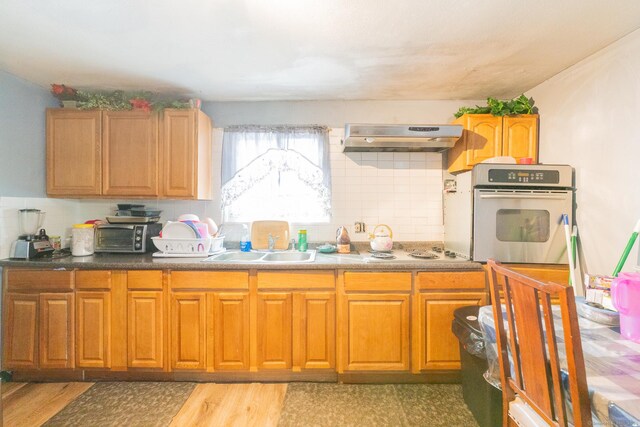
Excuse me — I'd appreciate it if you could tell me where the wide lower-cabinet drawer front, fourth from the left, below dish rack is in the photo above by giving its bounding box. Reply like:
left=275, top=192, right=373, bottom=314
left=170, top=271, right=249, bottom=289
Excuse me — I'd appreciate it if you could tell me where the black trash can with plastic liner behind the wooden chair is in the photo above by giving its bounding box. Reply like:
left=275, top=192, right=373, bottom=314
left=451, top=305, right=502, bottom=427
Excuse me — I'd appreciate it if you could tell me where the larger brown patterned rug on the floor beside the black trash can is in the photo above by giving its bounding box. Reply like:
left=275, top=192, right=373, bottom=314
left=279, top=383, right=478, bottom=427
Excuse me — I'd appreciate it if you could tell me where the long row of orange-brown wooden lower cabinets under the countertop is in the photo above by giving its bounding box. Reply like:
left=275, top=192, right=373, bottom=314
left=3, top=268, right=500, bottom=379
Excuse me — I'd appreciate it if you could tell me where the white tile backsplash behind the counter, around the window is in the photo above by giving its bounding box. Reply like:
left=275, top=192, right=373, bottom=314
left=0, top=129, right=443, bottom=259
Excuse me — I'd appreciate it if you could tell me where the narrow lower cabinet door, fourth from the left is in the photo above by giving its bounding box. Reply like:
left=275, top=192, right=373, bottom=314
left=127, top=292, right=164, bottom=368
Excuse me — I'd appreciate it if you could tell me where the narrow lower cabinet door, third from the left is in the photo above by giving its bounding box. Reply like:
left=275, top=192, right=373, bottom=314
left=76, top=291, right=111, bottom=368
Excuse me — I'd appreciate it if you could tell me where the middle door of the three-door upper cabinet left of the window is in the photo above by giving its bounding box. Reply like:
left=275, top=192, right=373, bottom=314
left=102, top=111, right=159, bottom=196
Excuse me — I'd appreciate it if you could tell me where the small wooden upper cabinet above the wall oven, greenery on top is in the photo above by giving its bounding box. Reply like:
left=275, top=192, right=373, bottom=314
left=447, top=114, right=538, bottom=173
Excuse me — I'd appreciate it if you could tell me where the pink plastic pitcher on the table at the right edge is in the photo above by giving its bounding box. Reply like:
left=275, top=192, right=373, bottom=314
left=611, top=273, right=640, bottom=343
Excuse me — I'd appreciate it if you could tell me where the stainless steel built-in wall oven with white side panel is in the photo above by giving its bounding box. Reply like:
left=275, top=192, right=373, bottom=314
left=444, top=163, right=574, bottom=264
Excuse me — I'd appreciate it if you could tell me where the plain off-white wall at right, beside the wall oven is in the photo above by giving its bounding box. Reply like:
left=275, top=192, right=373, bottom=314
left=527, top=31, right=640, bottom=274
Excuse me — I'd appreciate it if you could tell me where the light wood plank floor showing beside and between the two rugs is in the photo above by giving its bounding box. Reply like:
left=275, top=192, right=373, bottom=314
left=1, top=383, right=287, bottom=426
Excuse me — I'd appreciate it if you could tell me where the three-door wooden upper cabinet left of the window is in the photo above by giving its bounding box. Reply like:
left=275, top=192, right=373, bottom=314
left=47, top=108, right=213, bottom=199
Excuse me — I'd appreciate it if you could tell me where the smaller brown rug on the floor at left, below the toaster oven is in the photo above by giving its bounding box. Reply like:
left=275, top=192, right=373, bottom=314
left=44, top=382, right=196, bottom=427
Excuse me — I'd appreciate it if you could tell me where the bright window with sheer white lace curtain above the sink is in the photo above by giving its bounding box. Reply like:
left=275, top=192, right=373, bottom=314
left=221, top=126, right=331, bottom=223
